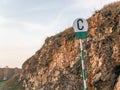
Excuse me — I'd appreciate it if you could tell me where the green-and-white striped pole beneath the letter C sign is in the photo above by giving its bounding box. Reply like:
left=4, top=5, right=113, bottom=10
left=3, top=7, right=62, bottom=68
left=80, top=39, right=88, bottom=90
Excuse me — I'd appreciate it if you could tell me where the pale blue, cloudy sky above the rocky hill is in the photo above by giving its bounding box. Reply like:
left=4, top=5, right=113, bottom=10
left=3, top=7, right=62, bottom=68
left=0, top=0, right=119, bottom=68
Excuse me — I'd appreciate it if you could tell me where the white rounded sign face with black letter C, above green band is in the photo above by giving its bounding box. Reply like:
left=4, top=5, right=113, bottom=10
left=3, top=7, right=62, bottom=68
left=73, top=18, right=88, bottom=32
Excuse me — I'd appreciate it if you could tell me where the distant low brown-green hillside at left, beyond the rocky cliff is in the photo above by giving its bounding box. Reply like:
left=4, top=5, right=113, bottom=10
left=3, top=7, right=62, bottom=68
left=0, top=66, right=24, bottom=90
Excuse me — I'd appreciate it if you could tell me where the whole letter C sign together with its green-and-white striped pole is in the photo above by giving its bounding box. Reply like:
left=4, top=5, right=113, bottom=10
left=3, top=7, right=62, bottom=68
left=73, top=18, right=88, bottom=90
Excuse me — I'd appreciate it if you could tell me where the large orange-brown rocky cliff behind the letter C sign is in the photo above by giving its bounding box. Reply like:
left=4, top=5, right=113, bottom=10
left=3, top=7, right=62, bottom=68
left=22, top=2, right=120, bottom=90
